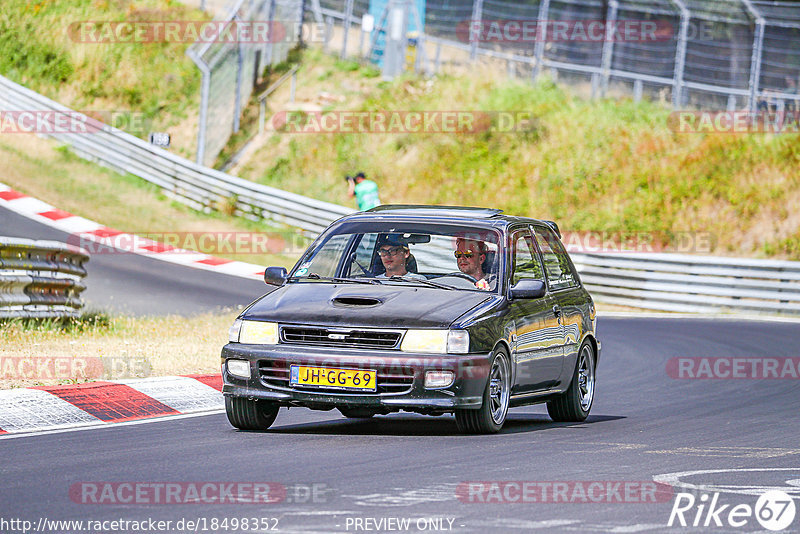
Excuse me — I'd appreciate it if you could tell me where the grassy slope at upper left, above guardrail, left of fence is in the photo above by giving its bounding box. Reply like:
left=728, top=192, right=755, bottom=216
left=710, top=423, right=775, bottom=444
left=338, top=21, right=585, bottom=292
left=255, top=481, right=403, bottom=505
left=0, top=0, right=209, bottom=156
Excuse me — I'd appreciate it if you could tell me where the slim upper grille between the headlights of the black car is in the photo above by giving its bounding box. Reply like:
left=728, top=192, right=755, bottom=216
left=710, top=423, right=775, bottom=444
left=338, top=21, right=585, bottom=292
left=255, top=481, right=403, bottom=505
left=281, top=326, right=401, bottom=349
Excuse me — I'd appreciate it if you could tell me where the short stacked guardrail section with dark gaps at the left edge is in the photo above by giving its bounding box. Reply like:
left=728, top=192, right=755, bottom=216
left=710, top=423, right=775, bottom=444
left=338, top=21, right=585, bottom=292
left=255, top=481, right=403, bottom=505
left=0, top=237, right=89, bottom=318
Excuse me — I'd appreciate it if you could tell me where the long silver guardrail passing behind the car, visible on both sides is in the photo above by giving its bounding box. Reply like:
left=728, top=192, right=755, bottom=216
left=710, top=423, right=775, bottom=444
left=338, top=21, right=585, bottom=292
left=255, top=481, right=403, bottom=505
left=0, top=77, right=800, bottom=315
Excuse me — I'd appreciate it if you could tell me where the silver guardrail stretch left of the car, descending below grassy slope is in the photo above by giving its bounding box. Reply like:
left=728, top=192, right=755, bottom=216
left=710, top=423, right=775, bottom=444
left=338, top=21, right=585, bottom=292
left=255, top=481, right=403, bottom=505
left=0, top=76, right=355, bottom=233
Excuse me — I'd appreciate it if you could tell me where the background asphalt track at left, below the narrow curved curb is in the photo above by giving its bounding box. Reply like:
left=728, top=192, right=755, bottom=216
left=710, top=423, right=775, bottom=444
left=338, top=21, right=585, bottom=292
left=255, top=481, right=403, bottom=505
left=0, top=204, right=268, bottom=316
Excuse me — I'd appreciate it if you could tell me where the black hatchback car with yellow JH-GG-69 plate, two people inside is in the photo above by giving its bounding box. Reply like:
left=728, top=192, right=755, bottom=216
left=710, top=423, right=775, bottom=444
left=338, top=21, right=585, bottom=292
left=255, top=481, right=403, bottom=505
left=222, top=206, right=600, bottom=433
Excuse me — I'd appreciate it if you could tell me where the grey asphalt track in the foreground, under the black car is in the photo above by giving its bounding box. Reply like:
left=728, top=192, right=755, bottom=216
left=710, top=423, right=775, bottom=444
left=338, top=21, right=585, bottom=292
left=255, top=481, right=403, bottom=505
left=0, top=318, right=800, bottom=533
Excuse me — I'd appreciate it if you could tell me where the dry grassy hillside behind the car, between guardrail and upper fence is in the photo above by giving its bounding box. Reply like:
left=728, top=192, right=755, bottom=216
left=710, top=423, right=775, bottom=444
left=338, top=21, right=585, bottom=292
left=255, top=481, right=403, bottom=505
left=237, top=50, right=800, bottom=259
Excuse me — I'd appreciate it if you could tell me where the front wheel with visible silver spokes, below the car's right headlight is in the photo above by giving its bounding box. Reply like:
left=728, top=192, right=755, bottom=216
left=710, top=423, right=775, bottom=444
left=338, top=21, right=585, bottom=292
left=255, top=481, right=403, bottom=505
left=456, top=348, right=511, bottom=434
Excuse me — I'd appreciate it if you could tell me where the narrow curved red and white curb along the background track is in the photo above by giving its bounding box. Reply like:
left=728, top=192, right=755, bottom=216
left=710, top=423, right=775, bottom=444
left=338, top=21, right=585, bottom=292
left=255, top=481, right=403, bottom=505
left=0, top=183, right=264, bottom=280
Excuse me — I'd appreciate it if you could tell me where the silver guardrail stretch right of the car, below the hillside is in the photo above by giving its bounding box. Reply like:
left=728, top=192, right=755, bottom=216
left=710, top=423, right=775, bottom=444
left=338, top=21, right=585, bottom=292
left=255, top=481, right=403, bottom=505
left=571, top=252, right=800, bottom=315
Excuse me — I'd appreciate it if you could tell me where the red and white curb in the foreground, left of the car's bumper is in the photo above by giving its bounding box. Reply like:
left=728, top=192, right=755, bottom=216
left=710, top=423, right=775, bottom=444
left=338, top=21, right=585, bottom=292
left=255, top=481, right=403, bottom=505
left=0, top=375, right=225, bottom=435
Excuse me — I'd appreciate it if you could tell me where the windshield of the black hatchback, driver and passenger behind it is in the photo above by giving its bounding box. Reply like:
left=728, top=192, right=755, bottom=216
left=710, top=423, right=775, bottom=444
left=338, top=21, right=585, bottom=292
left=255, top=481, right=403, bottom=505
left=291, top=222, right=501, bottom=292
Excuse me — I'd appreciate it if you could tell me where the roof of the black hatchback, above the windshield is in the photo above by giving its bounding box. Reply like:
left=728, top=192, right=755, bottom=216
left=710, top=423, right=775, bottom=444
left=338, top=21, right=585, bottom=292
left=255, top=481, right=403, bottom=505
left=339, top=204, right=561, bottom=237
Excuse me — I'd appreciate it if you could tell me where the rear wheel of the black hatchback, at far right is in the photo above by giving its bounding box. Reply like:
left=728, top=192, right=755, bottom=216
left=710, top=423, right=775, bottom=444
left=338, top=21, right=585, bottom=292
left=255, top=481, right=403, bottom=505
left=547, top=341, right=597, bottom=423
